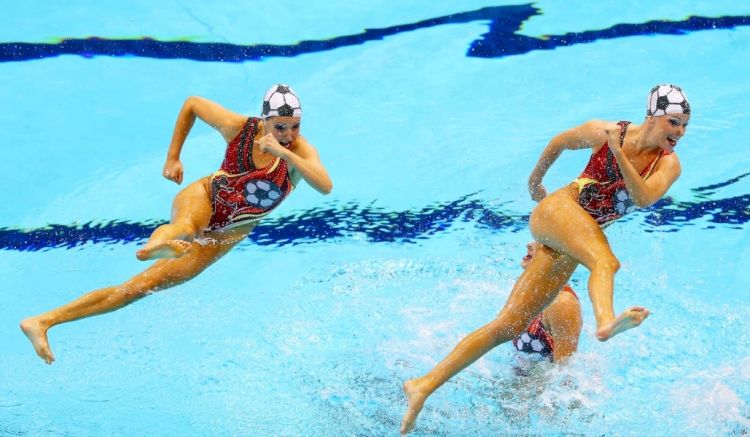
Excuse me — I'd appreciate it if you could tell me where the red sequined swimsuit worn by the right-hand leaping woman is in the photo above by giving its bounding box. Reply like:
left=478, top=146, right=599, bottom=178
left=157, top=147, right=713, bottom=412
left=574, top=121, right=664, bottom=226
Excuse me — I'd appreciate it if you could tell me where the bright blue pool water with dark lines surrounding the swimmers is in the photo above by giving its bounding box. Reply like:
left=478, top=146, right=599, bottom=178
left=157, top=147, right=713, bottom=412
left=0, top=1, right=750, bottom=436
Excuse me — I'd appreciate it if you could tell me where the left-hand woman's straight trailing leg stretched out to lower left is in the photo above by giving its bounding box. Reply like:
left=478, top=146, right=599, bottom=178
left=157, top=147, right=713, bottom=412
left=21, top=229, right=244, bottom=364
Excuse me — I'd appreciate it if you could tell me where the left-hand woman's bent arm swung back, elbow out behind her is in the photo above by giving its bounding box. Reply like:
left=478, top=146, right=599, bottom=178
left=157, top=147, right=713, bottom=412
left=162, top=96, right=247, bottom=184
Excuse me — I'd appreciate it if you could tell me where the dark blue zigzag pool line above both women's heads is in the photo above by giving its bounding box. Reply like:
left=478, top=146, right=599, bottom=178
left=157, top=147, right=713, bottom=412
left=0, top=4, right=750, bottom=62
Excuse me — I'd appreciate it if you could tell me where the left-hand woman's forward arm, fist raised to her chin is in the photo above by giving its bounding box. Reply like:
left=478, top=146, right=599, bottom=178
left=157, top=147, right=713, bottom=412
left=260, top=134, right=333, bottom=194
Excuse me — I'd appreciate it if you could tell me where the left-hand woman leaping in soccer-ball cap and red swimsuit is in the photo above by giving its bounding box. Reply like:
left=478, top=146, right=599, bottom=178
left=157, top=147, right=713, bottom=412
left=21, top=84, right=333, bottom=364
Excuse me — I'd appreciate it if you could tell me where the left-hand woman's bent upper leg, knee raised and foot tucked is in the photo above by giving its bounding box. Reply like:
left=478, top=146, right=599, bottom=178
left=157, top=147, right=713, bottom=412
left=135, top=179, right=212, bottom=261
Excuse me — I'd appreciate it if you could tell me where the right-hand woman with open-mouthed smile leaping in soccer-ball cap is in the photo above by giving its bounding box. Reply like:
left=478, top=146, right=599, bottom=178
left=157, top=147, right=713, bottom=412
left=401, top=85, right=690, bottom=433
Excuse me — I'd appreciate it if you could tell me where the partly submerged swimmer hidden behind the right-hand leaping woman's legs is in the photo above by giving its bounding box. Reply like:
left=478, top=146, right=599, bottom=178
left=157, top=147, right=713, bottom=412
left=511, top=242, right=583, bottom=363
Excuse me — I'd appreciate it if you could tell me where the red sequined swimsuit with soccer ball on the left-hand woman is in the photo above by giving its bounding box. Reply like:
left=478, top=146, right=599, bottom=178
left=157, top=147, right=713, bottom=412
left=208, top=117, right=294, bottom=231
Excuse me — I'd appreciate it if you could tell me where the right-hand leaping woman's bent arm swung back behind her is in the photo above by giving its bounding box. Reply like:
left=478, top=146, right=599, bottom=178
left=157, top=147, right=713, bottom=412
left=529, top=120, right=607, bottom=202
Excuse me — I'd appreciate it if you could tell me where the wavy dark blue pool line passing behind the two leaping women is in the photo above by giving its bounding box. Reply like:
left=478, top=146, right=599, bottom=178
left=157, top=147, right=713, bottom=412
left=0, top=187, right=750, bottom=251
